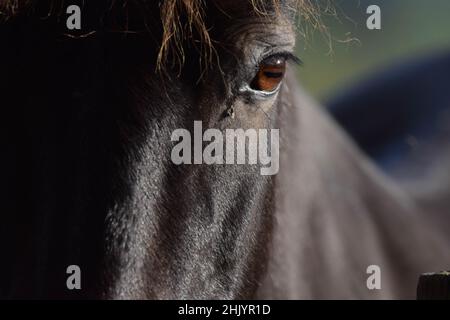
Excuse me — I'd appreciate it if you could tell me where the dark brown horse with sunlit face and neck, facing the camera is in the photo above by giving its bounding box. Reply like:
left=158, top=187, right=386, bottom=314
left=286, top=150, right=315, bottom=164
left=0, top=0, right=450, bottom=299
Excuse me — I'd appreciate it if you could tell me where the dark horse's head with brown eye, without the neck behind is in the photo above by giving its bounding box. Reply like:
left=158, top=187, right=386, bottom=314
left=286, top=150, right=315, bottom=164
left=1, top=0, right=302, bottom=298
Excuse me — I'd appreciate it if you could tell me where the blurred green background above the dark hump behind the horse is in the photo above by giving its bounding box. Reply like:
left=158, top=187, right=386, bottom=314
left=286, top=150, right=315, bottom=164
left=297, top=0, right=450, bottom=102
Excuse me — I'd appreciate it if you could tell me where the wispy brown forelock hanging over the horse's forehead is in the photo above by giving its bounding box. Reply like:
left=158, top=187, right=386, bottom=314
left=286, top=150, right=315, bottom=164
left=0, top=0, right=321, bottom=69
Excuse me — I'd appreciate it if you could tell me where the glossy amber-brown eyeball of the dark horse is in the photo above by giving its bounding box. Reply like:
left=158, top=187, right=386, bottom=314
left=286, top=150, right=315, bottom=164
left=250, top=57, right=286, bottom=92
